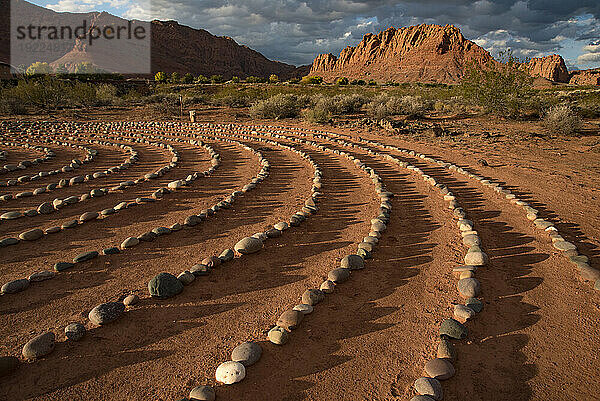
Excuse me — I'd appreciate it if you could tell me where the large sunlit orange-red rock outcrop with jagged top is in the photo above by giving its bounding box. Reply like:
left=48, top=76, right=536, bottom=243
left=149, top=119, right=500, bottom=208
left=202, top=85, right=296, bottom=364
left=310, top=24, right=495, bottom=83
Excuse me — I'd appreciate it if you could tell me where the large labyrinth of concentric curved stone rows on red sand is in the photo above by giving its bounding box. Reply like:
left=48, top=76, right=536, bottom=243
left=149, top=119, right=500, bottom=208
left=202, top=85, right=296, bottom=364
left=0, top=122, right=600, bottom=401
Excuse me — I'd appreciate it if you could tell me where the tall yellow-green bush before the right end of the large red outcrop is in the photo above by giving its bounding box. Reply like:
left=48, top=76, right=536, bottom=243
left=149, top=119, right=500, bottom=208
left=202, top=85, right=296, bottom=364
left=461, top=53, right=533, bottom=118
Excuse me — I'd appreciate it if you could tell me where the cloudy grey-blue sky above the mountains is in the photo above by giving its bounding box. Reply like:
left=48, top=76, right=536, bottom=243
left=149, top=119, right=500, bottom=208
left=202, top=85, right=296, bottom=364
left=28, top=0, right=600, bottom=69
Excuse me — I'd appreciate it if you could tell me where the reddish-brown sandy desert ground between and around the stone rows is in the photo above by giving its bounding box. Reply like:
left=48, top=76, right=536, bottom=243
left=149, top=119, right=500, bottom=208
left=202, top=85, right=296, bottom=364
left=0, top=110, right=600, bottom=401
